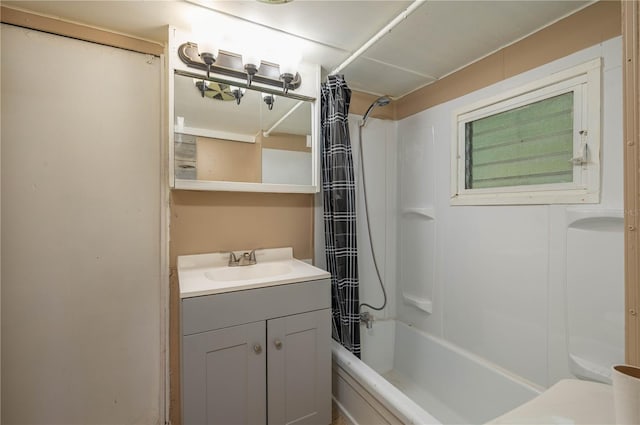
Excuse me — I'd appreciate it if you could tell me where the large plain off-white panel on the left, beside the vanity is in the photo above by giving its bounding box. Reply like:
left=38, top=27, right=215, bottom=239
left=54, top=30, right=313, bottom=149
left=2, top=25, right=164, bottom=424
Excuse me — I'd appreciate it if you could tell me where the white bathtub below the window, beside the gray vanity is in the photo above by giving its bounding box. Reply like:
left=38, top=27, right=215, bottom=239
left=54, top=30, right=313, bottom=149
left=332, top=320, right=542, bottom=425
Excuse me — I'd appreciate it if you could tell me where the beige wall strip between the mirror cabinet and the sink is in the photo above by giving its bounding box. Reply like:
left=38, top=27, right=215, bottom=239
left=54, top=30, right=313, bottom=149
left=170, top=190, right=313, bottom=267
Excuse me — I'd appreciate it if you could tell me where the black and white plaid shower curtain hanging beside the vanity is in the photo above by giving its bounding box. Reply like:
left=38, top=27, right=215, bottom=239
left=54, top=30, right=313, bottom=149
left=321, top=75, right=360, bottom=357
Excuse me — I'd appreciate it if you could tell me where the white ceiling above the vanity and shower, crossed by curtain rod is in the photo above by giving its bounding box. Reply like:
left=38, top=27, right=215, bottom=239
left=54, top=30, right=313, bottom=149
left=2, top=0, right=593, bottom=97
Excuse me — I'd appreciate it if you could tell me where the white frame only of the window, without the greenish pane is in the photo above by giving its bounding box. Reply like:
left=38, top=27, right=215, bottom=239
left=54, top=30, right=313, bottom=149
left=450, top=58, right=602, bottom=205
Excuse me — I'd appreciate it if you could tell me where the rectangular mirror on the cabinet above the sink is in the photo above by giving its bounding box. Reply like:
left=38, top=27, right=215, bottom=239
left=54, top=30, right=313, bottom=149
left=174, top=74, right=315, bottom=191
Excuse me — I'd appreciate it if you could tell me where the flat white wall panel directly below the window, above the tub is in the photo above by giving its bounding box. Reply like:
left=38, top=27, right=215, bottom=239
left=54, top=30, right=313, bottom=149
left=443, top=207, right=548, bottom=383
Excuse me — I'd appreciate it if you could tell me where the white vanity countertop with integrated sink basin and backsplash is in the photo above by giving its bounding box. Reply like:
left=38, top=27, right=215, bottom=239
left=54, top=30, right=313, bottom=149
left=178, top=248, right=331, bottom=298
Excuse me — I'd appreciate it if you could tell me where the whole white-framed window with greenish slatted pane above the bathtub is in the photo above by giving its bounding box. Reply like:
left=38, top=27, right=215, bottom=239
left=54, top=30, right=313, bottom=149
left=451, top=59, right=601, bottom=205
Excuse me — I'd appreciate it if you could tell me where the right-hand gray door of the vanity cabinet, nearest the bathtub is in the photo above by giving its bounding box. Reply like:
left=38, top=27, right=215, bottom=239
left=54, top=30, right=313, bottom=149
left=267, top=309, right=331, bottom=425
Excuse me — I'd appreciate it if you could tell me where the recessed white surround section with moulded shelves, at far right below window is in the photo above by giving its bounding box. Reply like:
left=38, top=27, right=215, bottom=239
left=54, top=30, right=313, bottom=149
left=566, top=210, right=624, bottom=383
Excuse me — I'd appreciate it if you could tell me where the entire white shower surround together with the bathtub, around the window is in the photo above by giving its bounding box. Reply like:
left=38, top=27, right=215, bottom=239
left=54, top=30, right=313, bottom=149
left=333, top=37, right=624, bottom=423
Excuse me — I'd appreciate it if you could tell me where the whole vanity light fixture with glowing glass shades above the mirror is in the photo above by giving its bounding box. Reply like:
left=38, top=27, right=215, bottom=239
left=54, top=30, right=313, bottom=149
left=178, top=42, right=302, bottom=93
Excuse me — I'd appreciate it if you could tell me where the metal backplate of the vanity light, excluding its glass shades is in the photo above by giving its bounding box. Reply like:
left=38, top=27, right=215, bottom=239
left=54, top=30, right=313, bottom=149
left=178, top=41, right=302, bottom=90
